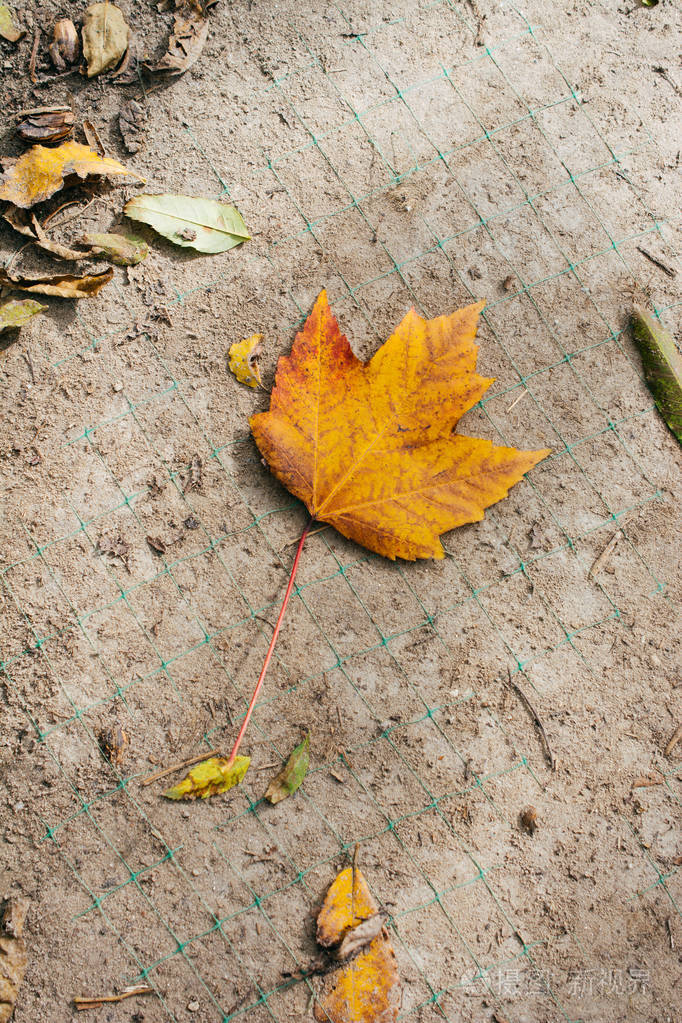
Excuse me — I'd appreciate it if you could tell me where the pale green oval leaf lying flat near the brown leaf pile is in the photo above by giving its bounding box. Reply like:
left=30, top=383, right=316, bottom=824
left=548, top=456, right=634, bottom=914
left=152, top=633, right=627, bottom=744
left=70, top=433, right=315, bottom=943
left=124, top=195, right=251, bottom=253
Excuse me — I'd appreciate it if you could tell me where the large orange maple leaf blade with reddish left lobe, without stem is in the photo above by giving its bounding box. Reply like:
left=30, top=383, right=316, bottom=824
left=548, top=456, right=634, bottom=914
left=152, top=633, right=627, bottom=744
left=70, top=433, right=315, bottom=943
left=251, top=292, right=549, bottom=561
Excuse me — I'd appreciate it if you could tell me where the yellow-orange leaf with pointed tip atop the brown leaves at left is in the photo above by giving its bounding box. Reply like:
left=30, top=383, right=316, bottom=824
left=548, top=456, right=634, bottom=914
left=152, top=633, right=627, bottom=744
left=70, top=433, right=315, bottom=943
left=0, top=141, right=143, bottom=210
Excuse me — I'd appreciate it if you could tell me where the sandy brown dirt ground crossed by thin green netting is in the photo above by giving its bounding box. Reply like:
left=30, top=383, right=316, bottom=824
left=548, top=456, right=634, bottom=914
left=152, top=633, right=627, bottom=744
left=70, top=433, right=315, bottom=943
left=0, top=0, right=682, bottom=1023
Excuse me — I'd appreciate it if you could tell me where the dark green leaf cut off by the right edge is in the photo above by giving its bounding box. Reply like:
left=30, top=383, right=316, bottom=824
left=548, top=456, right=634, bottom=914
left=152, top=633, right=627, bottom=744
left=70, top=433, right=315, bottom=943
left=631, top=306, right=682, bottom=444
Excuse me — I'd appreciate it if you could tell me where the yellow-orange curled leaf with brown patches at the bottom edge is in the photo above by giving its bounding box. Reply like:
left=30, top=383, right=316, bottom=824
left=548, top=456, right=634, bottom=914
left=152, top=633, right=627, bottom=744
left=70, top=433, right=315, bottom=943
left=314, top=866, right=401, bottom=1023
